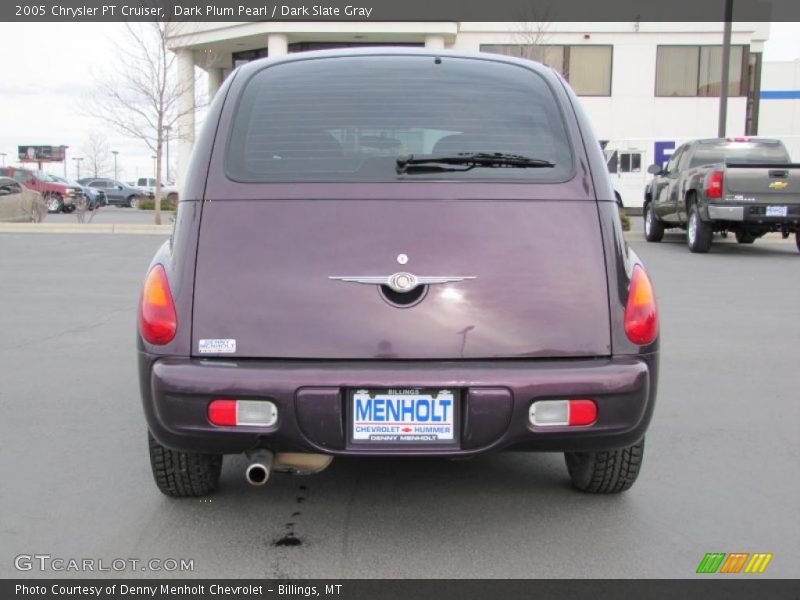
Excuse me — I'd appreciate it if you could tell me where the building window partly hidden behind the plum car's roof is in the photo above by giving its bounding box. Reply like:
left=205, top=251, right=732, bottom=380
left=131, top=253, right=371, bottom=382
left=481, top=44, right=613, bottom=96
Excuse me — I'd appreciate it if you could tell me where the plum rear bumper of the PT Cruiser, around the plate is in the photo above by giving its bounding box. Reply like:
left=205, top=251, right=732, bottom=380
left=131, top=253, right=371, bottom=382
left=139, top=353, right=658, bottom=456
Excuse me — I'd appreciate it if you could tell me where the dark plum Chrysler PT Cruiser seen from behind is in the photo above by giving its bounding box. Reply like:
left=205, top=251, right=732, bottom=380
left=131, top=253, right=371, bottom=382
left=138, top=48, right=658, bottom=496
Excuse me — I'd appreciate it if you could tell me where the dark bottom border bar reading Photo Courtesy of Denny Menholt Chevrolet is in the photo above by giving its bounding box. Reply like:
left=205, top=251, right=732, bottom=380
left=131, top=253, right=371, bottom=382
left=0, top=575, right=800, bottom=600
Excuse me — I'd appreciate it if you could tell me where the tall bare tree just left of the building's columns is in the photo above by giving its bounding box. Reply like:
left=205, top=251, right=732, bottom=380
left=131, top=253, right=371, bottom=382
left=89, top=22, right=212, bottom=225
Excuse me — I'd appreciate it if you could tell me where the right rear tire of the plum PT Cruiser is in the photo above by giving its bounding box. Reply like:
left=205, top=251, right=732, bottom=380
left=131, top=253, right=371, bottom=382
left=564, top=439, right=644, bottom=494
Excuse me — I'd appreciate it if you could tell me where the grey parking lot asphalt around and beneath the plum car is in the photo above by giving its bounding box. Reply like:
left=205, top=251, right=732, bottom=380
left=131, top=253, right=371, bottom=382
left=0, top=229, right=800, bottom=578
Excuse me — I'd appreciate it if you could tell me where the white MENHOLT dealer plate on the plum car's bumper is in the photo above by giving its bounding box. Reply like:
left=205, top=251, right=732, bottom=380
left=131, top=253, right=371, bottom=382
left=350, top=389, right=456, bottom=444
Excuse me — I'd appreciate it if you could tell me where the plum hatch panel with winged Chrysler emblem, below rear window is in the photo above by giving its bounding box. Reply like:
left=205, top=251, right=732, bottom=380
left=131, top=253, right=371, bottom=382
left=192, top=199, right=610, bottom=359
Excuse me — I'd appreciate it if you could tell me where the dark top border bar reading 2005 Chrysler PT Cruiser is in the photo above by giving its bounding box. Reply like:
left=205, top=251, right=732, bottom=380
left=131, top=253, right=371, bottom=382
left=0, top=0, right=800, bottom=23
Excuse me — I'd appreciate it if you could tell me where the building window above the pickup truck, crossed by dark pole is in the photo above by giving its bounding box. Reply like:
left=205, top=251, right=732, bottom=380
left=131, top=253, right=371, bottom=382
left=656, top=46, right=748, bottom=97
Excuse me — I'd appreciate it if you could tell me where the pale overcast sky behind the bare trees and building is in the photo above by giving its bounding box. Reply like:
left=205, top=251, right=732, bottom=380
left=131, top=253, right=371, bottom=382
left=0, top=23, right=800, bottom=180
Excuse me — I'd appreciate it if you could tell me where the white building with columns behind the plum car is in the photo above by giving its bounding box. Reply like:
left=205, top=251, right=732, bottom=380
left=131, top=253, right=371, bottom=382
left=170, top=22, right=800, bottom=208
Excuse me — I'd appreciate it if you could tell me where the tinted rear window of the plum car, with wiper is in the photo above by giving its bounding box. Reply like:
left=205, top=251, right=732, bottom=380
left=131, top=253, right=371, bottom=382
left=226, top=56, right=573, bottom=182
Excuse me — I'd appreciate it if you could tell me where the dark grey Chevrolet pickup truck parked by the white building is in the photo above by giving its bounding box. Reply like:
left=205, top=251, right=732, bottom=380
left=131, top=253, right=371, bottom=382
left=644, top=138, right=800, bottom=252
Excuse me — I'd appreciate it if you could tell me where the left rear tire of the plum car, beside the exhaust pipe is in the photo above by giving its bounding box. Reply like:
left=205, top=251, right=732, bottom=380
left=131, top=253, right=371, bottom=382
left=147, top=431, right=222, bottom=498
